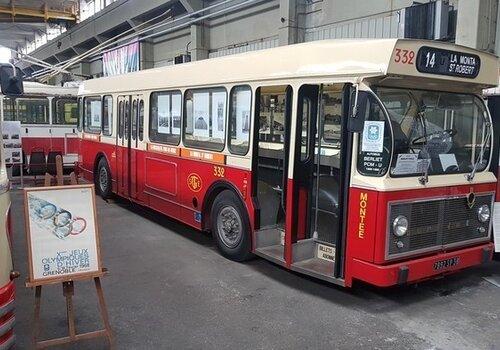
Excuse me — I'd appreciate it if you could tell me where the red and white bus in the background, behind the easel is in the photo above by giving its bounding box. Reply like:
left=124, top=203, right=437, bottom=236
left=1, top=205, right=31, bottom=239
left=0, top=82, right=78, bottom=165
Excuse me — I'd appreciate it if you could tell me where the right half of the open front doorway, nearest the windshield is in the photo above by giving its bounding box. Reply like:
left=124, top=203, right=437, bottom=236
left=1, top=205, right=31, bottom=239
left=287, top=84, right=350, bottom=280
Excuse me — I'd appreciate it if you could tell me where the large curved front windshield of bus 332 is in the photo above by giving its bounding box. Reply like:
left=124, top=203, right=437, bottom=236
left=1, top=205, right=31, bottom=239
left=376, top=87, right=492, bottom=177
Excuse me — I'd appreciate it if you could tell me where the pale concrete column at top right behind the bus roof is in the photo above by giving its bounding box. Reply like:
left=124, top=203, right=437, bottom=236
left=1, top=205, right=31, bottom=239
left=455, top=0, right=498, bottom=52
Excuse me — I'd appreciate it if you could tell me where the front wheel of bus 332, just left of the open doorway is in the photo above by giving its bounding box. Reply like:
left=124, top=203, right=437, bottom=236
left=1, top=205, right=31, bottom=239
left=210, top=190, right=251, bottom=261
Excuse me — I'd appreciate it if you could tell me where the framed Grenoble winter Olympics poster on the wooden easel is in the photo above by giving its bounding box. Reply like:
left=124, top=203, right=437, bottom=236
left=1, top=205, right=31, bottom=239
left=24, top=185, right=102, bottom=286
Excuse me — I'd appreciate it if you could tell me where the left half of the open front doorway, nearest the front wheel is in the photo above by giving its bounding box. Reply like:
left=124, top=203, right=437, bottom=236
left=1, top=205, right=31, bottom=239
left=252, top=85, right=292, bottom=265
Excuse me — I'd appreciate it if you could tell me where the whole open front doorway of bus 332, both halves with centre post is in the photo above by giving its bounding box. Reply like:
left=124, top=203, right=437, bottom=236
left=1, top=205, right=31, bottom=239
left=254, top=84, right=356, bottom=280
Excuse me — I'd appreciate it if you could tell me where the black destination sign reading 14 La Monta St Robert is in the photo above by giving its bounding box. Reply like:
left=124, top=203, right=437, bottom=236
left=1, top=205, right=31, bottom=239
left=417, top=46, right=481, bottom=79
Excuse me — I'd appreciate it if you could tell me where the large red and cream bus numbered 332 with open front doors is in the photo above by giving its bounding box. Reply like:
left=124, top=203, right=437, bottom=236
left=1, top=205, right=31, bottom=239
left=79, top=39, right=498, bottom=286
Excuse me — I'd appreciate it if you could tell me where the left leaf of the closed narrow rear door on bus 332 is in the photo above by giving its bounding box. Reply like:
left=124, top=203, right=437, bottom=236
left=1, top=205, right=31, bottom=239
left=116, top=96, right=132, bottom=197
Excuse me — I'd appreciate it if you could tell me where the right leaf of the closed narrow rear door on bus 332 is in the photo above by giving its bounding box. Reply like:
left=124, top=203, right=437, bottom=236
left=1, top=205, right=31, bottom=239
left=128, top=95, right=144, bottom=199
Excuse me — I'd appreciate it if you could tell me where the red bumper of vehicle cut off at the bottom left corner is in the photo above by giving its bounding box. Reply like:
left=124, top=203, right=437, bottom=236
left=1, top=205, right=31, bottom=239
left=0, top=281, right=16, bottom=350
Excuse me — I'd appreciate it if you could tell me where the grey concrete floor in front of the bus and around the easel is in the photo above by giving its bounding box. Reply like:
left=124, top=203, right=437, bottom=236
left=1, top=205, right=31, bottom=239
left=6, top=191, right=500, bottom=349
